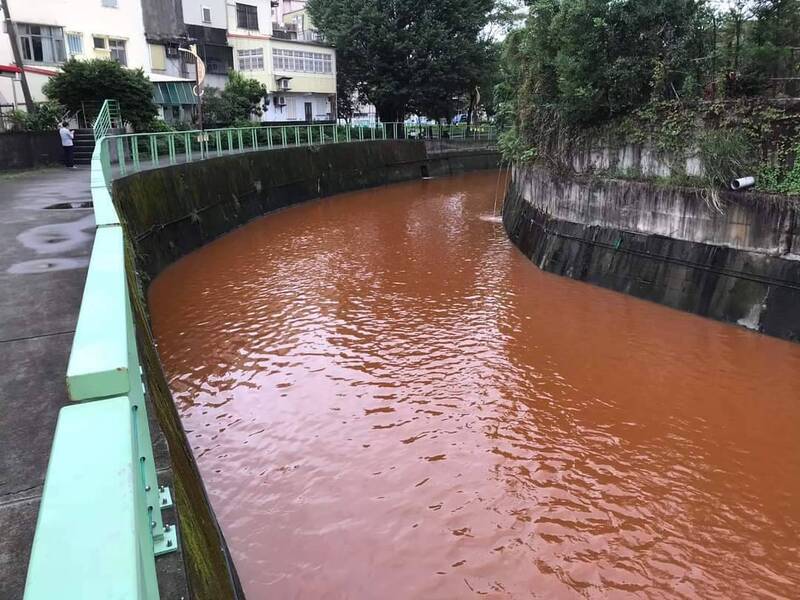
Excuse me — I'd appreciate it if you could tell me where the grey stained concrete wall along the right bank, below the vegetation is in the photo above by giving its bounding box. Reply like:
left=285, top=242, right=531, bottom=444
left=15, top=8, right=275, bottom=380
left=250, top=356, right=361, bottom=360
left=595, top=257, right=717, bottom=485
left=503, top=166, right=800, bottom=341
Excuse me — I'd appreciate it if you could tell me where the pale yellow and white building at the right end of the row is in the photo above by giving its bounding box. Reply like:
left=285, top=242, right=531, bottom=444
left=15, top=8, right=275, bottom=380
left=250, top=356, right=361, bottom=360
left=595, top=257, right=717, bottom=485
left=228, top=0, right=336, bottom=122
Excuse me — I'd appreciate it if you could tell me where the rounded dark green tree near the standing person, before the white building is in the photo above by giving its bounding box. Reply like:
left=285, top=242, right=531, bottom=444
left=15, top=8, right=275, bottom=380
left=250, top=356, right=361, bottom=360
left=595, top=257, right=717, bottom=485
left=42, top=58, right=158, bottom=131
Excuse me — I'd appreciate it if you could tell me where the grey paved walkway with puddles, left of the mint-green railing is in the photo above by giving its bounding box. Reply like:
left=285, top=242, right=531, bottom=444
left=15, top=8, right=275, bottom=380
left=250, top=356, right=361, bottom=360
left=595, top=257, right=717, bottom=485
left=0, top=167, right=188, bottom=600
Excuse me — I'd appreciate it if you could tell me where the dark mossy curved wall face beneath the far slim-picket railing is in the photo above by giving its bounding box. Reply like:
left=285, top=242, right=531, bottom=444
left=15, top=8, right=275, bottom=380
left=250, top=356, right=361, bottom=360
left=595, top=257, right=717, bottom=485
left=113, top=141, right=499, bottom=280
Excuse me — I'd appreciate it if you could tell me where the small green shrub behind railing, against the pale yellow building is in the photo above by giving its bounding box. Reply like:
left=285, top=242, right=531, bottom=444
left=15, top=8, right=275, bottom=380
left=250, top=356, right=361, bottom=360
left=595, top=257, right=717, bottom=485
left=203, top=71, right=267, bottom=127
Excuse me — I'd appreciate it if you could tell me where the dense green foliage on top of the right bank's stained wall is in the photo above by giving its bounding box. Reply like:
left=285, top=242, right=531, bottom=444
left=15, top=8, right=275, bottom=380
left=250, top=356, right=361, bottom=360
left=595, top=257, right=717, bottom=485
left=504, top=0, right=800, bottom=146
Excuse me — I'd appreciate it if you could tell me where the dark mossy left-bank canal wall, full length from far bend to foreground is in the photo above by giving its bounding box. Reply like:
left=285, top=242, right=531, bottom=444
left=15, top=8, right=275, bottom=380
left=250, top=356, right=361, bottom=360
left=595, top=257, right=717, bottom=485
left=112, top=140, right=499, bottom=600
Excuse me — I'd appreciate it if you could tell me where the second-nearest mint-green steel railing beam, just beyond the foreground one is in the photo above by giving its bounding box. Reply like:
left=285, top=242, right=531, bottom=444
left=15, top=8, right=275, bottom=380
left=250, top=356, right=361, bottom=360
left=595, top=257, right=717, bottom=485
left=67, top=226, right=130, bottom=400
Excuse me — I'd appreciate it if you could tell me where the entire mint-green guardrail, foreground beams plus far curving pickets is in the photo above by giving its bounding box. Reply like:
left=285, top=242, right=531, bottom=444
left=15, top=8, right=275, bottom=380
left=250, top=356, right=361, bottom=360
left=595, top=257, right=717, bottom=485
left=25, top=101, right=497, bottom=600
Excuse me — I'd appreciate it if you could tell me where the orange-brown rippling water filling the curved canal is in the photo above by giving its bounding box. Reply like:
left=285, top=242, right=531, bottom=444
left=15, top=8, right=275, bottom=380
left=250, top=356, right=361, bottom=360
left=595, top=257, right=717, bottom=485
left=150, top=172, right=800, bottom=599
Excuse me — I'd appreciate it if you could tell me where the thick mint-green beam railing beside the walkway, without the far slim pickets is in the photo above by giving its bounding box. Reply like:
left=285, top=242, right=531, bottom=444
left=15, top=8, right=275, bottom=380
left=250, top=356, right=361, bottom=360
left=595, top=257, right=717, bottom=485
left=25, top=101, right=178, bottom=600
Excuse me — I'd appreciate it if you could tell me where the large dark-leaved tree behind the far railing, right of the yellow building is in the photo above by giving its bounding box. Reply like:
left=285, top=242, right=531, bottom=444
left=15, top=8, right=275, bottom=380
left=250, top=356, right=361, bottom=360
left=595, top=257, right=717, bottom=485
left=307, top=0, right=494, bottom=121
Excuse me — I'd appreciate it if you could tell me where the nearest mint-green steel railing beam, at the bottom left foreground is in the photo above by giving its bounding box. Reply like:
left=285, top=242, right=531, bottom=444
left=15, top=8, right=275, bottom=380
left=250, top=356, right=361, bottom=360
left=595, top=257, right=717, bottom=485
left=24, top=396, right=148, bottom=600
